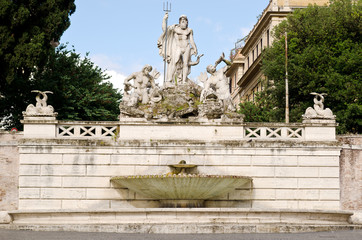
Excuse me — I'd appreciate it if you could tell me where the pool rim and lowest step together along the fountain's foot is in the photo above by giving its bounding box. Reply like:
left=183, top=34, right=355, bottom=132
left=0, top=208, right=362, bottom=233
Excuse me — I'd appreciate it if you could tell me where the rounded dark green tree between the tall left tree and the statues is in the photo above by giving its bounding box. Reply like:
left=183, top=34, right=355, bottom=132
left=34, top=45, right=122, bottom=121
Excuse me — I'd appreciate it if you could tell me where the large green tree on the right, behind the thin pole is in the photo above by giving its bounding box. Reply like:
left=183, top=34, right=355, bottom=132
left=262, top=0, right=362, bottom=133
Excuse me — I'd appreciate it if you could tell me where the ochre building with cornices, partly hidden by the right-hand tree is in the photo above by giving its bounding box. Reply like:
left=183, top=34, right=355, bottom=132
left=227, top=0, right=329, bottom=106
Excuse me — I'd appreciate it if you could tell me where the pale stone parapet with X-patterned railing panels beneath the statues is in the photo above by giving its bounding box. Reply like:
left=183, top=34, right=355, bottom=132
left=23, top=118, right=337, bottom=141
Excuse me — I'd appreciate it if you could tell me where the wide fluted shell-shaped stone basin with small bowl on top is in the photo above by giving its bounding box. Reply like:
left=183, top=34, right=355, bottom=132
left=111, top=160, right=252, bottom=208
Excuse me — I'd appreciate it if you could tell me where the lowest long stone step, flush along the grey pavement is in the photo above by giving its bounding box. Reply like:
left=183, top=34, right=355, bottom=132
left=0, top=223, right=362, bottom=234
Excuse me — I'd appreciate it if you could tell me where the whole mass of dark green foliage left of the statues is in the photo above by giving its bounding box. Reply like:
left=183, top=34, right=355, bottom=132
left=0, top=0, right=121, bottom=129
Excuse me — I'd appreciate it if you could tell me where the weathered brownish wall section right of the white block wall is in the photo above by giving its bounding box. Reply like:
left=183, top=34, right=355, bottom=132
left=338, top=135, right=362, bottom=210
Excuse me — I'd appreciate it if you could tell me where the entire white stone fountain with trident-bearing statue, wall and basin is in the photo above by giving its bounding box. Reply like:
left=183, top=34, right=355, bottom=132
left=8, top=7, right=351, bottom=233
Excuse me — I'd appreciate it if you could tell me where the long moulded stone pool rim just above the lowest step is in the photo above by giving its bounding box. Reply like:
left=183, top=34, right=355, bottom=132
left=9, top=208, right=353, bottom=226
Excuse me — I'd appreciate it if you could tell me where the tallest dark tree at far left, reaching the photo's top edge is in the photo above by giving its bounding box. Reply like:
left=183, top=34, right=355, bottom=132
left=0, top=0, right=75, bottom=128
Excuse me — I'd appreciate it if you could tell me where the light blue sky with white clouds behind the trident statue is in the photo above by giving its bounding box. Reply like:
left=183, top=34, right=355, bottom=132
left=60, top=0, right=269, bottom=89
